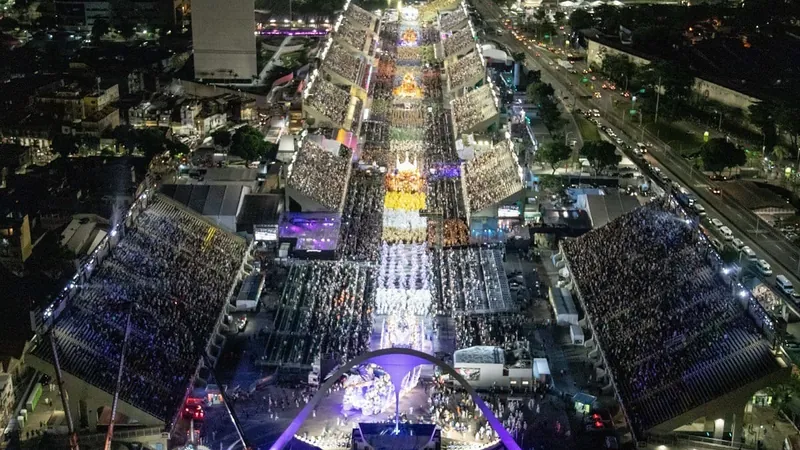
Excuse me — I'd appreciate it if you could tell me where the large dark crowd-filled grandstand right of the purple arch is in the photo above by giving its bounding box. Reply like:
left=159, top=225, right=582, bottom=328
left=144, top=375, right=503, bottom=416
left=562, top=200, right=788, bottom=442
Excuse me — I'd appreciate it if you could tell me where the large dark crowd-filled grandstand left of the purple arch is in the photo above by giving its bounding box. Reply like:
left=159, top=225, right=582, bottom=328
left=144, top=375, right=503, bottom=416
left=28, top=195, right=246, bottom=429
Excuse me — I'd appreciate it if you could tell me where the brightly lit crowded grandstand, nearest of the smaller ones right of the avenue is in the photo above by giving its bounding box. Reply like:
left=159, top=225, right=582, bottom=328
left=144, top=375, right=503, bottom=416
left=465, top=141, right=523, bottom=214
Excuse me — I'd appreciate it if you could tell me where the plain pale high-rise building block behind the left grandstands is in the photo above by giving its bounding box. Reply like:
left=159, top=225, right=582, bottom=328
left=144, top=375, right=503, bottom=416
left=192, top=0, right=257, bottom=82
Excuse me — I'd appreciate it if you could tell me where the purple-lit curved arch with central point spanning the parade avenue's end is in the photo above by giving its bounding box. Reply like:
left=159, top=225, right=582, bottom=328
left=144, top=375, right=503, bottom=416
left=270, top=348, right=521, bottom=450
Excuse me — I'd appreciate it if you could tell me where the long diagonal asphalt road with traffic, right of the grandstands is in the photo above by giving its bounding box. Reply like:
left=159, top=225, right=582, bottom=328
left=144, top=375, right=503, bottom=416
left=473, top=0, right=800, bottom=312
